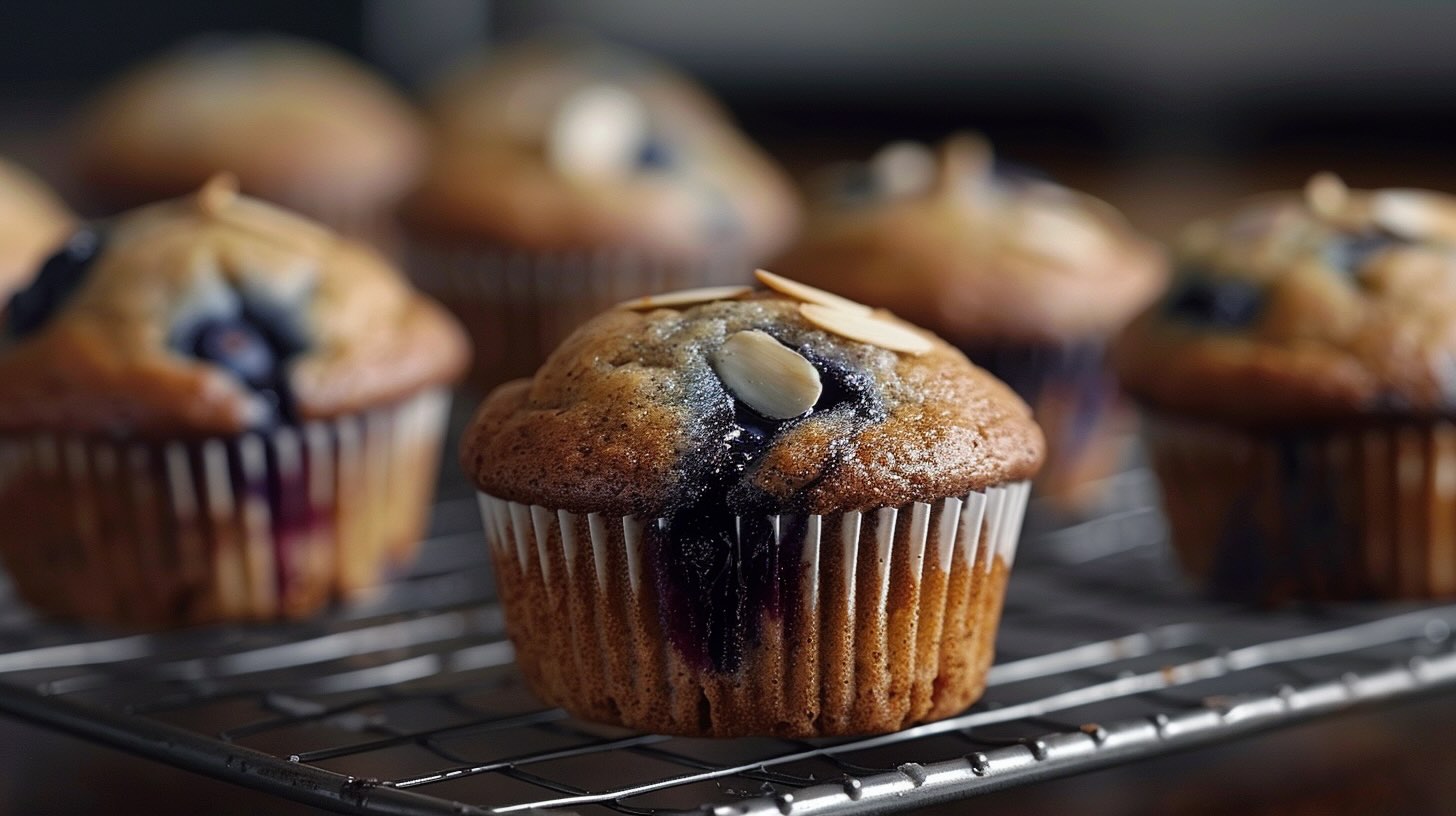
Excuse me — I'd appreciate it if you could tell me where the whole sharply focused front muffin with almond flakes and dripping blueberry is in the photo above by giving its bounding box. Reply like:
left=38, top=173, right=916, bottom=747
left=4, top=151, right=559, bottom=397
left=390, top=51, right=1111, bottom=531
left=462, top=274, right=1042, bottom=736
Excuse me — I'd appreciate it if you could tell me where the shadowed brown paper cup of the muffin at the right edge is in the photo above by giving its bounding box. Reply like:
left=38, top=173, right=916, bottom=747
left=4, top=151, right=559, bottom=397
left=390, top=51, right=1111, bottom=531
left=1144, top=417, right=1456, bottom=603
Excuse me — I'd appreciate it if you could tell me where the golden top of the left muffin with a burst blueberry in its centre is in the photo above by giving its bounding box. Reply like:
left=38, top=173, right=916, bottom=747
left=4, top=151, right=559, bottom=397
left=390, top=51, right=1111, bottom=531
left=0, top=176, right=467, bottom=437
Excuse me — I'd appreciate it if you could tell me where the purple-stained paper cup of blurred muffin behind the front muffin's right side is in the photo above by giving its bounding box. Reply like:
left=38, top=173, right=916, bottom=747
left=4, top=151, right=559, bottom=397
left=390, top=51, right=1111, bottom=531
left=961, top=340, right=1136, bottom=513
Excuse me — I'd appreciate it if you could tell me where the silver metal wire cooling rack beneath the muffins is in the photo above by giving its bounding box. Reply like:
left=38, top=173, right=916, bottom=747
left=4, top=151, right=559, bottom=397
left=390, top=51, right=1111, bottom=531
left=0, top=463, right=1456, bottom=816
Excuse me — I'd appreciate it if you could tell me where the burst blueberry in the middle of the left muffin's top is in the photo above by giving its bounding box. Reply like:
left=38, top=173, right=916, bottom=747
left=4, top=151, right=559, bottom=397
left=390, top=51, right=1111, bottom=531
left=172, top=299, right=307, bottom=423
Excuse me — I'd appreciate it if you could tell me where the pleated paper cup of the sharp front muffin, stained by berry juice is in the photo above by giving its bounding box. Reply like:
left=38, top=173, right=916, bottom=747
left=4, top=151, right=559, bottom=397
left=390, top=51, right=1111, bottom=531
left=480, top=482, right=1031, bottom=737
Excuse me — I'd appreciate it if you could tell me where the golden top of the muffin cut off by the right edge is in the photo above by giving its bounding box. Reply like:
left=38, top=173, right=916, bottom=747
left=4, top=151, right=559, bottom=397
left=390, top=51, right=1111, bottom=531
left=1115, top=173, right=1456, bottom=424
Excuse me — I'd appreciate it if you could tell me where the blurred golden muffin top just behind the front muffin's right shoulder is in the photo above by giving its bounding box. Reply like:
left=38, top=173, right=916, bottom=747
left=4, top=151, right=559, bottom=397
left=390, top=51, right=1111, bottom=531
left=776, top=134, right=1166, bottom=347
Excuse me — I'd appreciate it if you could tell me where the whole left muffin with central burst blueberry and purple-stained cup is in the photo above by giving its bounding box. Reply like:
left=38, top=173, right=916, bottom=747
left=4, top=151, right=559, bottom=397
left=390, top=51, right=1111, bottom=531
left=0, top=178, right=467, bottom=628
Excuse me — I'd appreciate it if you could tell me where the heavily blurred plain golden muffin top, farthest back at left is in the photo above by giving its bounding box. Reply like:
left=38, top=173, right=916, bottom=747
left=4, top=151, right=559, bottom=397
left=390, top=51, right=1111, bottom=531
left=76, top=35, right=425, bottom=211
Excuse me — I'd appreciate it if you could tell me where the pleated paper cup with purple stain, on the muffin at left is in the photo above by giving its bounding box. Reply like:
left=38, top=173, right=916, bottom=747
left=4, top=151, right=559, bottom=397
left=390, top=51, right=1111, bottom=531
left=0, top=391, right=448, bottom=628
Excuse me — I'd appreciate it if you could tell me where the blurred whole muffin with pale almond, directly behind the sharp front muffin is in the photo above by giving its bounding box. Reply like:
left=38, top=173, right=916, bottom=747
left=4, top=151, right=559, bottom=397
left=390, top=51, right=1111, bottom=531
left=405, top=39, right=798, bottom=386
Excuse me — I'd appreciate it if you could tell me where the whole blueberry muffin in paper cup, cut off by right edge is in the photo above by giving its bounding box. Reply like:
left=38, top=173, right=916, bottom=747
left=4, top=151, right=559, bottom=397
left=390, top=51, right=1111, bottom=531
left=1115, top=175, right=1456, bottom=602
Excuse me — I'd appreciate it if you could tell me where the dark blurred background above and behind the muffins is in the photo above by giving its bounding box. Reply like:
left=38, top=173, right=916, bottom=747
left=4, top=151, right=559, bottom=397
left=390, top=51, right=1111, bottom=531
left=0, top=0, right=1456, bottom=235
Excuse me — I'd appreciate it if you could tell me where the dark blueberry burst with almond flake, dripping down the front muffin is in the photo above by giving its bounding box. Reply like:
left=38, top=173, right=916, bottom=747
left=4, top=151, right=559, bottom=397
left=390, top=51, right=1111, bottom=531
left=648, top=329, right=882, bottom=672
